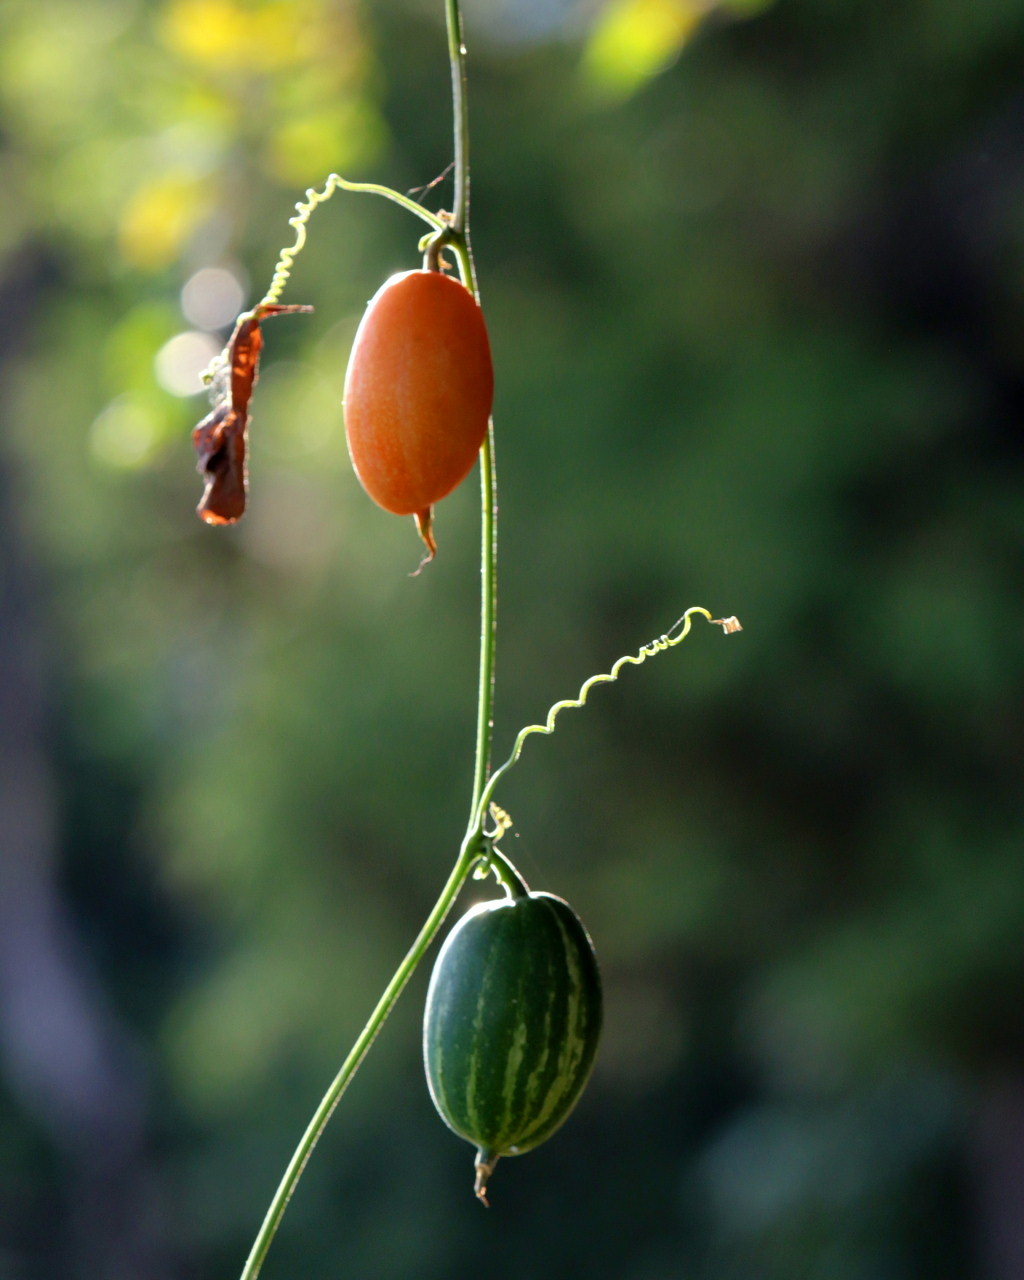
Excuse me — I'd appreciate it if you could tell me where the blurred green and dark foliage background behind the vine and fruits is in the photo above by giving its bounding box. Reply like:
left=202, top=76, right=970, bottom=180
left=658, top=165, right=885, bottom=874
left=0, top=0, right=1024, bottom=1280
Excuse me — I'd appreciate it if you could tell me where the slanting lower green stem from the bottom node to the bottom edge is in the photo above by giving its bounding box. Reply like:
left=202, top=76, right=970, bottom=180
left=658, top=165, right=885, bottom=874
left=241, top=837, right=486, bottom=1280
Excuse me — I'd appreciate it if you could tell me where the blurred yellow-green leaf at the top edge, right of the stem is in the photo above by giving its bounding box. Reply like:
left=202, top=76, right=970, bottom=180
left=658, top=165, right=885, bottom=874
left=584, top=0, right=708, bottom=97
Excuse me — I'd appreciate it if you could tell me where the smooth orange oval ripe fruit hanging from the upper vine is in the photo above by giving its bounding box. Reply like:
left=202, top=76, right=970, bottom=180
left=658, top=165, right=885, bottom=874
left=344, top=271, right=494, bottom=530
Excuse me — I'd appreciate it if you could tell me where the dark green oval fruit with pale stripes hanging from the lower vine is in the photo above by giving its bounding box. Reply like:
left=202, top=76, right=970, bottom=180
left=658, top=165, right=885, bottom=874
left=424, top=893, right=602, bottom=1203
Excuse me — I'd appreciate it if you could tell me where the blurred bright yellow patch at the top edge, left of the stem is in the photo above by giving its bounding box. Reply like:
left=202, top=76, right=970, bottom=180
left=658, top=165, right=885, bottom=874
left=163, top=0, right=319, bottom=73
